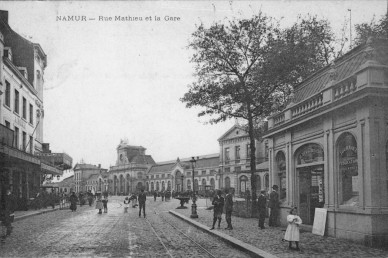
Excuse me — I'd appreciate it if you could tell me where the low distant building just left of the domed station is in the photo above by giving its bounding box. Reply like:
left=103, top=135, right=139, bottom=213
left=73, top=163, right=108, bottom=193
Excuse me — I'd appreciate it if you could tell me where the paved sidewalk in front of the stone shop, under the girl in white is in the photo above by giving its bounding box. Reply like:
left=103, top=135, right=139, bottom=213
left=173, top=199, right=388, bottom=258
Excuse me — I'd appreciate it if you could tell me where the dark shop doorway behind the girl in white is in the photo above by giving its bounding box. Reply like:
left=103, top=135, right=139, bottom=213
left=298, top=166, right=325, bottom=225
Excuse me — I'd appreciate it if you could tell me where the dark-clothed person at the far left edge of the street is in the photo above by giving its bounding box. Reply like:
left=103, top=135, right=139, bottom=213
left=1, top=189, right=16, bottom=243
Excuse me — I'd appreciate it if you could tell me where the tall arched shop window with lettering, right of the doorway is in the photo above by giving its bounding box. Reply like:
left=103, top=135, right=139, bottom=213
left=338, top=133, right=359, bottom=206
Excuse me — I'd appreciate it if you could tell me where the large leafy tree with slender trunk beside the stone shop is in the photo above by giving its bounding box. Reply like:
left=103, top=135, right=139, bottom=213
left=181, top=12, right=342, bottom=210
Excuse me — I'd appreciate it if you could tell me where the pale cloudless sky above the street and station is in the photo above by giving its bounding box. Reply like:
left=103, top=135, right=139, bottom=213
left=0, top=0, right=387, bottom=173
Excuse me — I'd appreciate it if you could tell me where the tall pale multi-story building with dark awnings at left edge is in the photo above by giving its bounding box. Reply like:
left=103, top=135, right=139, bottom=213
left=0, top=11, right=71, bottom=208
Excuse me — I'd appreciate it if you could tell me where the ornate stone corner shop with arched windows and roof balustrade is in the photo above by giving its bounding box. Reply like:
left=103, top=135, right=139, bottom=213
left=265, top=37, right=388, bottom=245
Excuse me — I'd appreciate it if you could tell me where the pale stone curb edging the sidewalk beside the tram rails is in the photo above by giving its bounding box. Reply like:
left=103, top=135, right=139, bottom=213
left=168, top=210, right=277, bottom=258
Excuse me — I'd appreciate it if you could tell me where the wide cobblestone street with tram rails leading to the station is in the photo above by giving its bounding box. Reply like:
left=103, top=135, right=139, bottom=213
left=0, top=197, right=252, bottom=257
